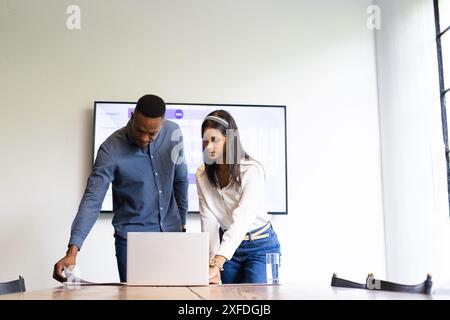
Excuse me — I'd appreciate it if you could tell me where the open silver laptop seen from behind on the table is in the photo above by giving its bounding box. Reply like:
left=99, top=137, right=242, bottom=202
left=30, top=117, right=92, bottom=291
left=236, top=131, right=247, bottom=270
left=127, top=232, right=209, bottom=286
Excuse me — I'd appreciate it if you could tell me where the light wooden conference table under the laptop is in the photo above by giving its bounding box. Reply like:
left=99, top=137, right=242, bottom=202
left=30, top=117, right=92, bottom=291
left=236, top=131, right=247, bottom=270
left=0, top=283, right=450, bottom=300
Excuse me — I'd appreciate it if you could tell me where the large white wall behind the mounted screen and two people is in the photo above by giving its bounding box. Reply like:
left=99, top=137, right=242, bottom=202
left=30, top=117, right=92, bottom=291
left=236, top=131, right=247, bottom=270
left=0, top=0, right=385, bottom=289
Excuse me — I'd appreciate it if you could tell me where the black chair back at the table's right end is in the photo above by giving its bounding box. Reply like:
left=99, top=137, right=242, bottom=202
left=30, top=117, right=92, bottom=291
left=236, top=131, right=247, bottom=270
left=331, top=273, right=433, bottom=294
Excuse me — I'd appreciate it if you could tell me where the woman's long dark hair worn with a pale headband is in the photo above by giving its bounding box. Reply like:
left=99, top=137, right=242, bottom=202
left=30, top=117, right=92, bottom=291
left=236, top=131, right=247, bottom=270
left=202, top=110, right=250, bottom=188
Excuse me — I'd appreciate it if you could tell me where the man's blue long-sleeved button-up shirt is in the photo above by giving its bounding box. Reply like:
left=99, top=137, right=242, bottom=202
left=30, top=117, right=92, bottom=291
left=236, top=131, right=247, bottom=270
left=69, top=120, right=189, bottom=249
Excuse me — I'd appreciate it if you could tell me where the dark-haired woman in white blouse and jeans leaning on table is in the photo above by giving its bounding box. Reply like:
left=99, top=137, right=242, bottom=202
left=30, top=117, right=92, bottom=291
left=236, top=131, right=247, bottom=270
left=197, top=110, right=280, bottom=283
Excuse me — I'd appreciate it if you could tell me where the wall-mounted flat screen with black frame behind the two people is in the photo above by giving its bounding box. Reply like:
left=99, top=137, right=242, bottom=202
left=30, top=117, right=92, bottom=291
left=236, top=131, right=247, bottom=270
left=93, top=101, right=288, bottom=214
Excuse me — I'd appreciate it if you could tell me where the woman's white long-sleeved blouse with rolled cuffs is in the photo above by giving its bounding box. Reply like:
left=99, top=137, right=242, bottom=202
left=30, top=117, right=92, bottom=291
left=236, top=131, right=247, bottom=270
left=197, top=159, right=270, bottom=260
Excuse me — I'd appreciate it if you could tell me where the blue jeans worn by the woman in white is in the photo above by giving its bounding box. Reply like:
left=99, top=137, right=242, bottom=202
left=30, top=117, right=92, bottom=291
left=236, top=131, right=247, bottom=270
left=221, top=226, right=280, bottom=284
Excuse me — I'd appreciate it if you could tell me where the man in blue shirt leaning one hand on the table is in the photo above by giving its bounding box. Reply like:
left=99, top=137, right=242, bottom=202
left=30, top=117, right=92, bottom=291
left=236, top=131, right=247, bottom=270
left=53, top=95, right=189, bottom=282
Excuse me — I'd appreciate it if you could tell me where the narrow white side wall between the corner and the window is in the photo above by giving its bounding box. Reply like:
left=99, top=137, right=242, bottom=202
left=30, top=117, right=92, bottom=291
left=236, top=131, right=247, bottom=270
left=375, top=0, right=450, bottom=283
